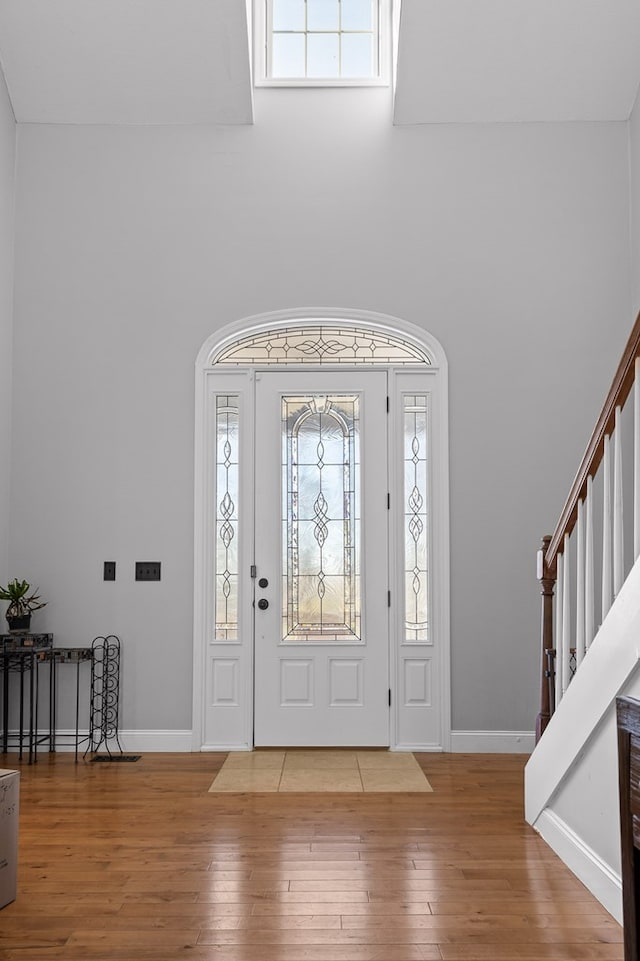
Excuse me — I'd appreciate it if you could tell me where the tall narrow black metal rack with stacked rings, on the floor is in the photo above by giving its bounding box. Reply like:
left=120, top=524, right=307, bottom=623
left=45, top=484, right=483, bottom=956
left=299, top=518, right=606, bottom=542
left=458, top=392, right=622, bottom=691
left=85, top=634, right=123, bottom=760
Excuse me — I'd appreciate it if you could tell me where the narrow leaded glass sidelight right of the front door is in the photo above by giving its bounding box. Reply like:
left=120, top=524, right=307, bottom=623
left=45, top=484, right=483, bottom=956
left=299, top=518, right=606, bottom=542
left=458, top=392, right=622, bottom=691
left=403, top=394, right=429, bottom=642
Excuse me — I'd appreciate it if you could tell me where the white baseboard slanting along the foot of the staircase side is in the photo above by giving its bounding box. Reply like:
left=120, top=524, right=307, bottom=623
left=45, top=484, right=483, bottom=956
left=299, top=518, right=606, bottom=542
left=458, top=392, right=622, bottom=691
left=533, top=808, right=622, bottom=924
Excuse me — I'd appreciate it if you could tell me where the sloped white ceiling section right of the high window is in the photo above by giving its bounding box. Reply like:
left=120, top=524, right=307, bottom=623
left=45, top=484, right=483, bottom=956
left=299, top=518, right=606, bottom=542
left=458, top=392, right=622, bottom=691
left=395, top=0, right=640, bottom=123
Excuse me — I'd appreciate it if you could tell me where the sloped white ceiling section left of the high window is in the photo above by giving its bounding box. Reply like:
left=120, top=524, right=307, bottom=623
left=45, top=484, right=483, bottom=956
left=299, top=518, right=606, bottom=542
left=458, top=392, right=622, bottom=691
left=0, top=0, right=252, bottom=124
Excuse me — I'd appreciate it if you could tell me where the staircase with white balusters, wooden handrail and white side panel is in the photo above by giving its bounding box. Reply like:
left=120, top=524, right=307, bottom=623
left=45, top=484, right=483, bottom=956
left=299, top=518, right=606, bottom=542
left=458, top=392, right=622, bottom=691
left=525, top=308, right=640, bottom=923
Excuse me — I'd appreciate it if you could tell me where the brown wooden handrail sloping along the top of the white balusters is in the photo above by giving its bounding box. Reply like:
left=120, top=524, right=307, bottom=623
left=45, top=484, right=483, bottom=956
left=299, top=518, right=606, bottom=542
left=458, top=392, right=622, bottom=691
left=544, top=314, right=640, bottom=578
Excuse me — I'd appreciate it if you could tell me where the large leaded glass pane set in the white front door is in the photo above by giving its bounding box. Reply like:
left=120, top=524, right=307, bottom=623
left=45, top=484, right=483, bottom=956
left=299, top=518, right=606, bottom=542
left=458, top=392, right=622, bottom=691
left=282, top=394, right=361, bottom=643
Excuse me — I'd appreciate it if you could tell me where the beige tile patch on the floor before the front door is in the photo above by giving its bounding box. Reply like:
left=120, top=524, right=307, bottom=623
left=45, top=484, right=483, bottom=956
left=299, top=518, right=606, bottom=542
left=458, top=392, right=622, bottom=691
left=209, top=749, right=433, bottom=793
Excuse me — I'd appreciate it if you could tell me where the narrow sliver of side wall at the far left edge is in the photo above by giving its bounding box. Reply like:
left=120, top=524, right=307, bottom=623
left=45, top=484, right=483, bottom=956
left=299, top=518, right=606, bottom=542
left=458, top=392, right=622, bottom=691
left=0, top=69, right=16, bottom=580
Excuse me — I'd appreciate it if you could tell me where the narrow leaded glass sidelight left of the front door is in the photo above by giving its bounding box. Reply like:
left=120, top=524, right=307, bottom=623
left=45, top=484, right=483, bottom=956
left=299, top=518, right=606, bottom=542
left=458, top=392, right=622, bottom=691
left=215, top=395, right=239, bottom=641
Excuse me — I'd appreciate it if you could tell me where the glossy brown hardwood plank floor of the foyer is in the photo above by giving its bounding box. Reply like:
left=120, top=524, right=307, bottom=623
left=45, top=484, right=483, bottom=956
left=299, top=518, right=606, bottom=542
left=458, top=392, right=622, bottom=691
left=0, top=754, right=623, bottom=961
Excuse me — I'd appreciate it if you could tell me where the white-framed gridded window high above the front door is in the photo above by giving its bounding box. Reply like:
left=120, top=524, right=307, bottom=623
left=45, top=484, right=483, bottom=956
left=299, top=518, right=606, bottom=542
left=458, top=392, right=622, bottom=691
left=255, top=0, right=388, bottom=86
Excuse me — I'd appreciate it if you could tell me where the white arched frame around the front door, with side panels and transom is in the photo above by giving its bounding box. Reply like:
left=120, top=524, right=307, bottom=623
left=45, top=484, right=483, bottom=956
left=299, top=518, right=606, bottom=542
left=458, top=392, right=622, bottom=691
left=193, top=308, right=450, bottom=750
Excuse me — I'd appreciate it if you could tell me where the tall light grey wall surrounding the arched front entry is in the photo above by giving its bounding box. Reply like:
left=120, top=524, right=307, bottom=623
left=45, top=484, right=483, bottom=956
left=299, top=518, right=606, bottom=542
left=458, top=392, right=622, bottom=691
left=11, top=90, right=632, bottom=731
